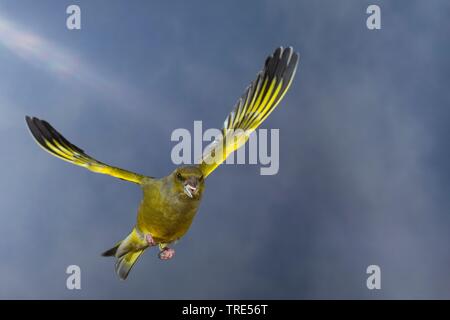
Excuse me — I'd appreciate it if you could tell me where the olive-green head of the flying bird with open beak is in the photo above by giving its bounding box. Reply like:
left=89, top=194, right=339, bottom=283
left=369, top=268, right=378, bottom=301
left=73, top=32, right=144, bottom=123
left=171, top=166, right=205, bottom=199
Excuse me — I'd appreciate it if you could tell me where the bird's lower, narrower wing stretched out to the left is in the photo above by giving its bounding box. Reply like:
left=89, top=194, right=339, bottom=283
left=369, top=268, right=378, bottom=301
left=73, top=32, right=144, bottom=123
left=25, top=116, right=147, bottom=184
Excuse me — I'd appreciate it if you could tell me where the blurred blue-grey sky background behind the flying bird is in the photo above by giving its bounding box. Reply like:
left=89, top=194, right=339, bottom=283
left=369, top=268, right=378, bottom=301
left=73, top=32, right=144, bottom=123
left=0, top=0, right=450, bottom=299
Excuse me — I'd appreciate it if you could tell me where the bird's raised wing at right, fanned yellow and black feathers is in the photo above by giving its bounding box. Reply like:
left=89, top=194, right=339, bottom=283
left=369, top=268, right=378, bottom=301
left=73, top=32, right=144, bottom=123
left=200, top=47, right=299, bottom=177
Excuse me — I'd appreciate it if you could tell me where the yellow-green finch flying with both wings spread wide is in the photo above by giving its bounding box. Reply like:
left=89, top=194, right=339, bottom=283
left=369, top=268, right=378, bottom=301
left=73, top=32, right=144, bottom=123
left=25, top=47, right=299, bottom=280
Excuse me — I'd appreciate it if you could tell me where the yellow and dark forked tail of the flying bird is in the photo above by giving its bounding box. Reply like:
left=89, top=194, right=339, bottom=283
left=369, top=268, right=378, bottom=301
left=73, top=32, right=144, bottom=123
left=102, top=229, right=148, bottom=280
